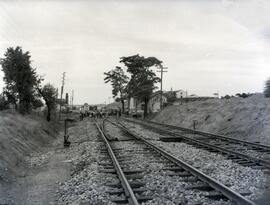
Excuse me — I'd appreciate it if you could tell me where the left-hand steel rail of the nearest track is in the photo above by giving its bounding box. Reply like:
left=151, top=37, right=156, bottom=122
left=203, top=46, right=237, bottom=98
left=95, top=123, right=139, bottom=205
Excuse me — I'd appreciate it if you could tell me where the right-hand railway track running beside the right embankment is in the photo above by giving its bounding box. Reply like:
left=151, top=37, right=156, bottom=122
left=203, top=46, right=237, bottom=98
left=124, top=118, right=270, bottom=169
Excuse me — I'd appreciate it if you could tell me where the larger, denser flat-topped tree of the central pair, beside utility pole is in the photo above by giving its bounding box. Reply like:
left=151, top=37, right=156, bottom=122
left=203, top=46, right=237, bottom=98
left=120, top=54, right=162, bottom=117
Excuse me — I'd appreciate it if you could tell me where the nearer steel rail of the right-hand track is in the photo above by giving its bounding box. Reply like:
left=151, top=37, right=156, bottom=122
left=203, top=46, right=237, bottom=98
left=123, top=120, right=270, bottom=169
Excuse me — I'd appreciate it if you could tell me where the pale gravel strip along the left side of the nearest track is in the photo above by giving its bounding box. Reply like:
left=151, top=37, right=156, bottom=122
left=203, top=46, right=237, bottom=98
left=58, top=119, right=116, bottom=205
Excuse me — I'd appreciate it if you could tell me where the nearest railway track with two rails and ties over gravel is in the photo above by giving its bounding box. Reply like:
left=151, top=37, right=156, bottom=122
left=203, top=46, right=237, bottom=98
left=96, top=118, right=256, bottom=205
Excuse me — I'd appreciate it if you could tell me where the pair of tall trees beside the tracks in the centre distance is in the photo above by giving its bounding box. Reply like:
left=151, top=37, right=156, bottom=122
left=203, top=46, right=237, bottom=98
left=104, top=54, right=162, bottom=117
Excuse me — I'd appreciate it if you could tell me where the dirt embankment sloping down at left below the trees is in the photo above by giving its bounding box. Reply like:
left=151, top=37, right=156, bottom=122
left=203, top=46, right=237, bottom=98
left=0, top=111, right=57, bottom=184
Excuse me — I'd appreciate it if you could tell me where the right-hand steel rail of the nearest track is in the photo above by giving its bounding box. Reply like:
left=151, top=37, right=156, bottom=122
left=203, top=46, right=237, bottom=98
left=111, top=122, right=257, bottom=205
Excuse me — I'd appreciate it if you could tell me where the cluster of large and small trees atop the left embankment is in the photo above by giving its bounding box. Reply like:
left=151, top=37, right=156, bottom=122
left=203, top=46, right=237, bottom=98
left=0, top=46, right=57, bottom=121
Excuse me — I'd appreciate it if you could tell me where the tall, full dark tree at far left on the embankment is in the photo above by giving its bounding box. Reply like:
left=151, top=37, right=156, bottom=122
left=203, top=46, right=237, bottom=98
left=0, top=47, right=41, bottom=114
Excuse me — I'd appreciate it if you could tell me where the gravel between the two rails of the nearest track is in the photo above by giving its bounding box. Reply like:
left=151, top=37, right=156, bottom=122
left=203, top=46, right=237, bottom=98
left=106, top=121, right=236, bottom=205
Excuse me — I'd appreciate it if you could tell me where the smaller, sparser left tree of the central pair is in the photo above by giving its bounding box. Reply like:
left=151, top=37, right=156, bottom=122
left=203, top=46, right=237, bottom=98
left=104, top=66, right=128, bottom=112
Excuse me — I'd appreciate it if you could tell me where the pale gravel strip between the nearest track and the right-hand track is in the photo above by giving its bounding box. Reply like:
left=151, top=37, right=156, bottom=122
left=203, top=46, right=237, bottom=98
left=121, top=119, right=270, bottom=199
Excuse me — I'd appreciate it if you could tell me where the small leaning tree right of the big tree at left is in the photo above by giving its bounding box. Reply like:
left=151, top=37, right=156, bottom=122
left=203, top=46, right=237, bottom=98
left=37, top=83, right=57, bottom=121
